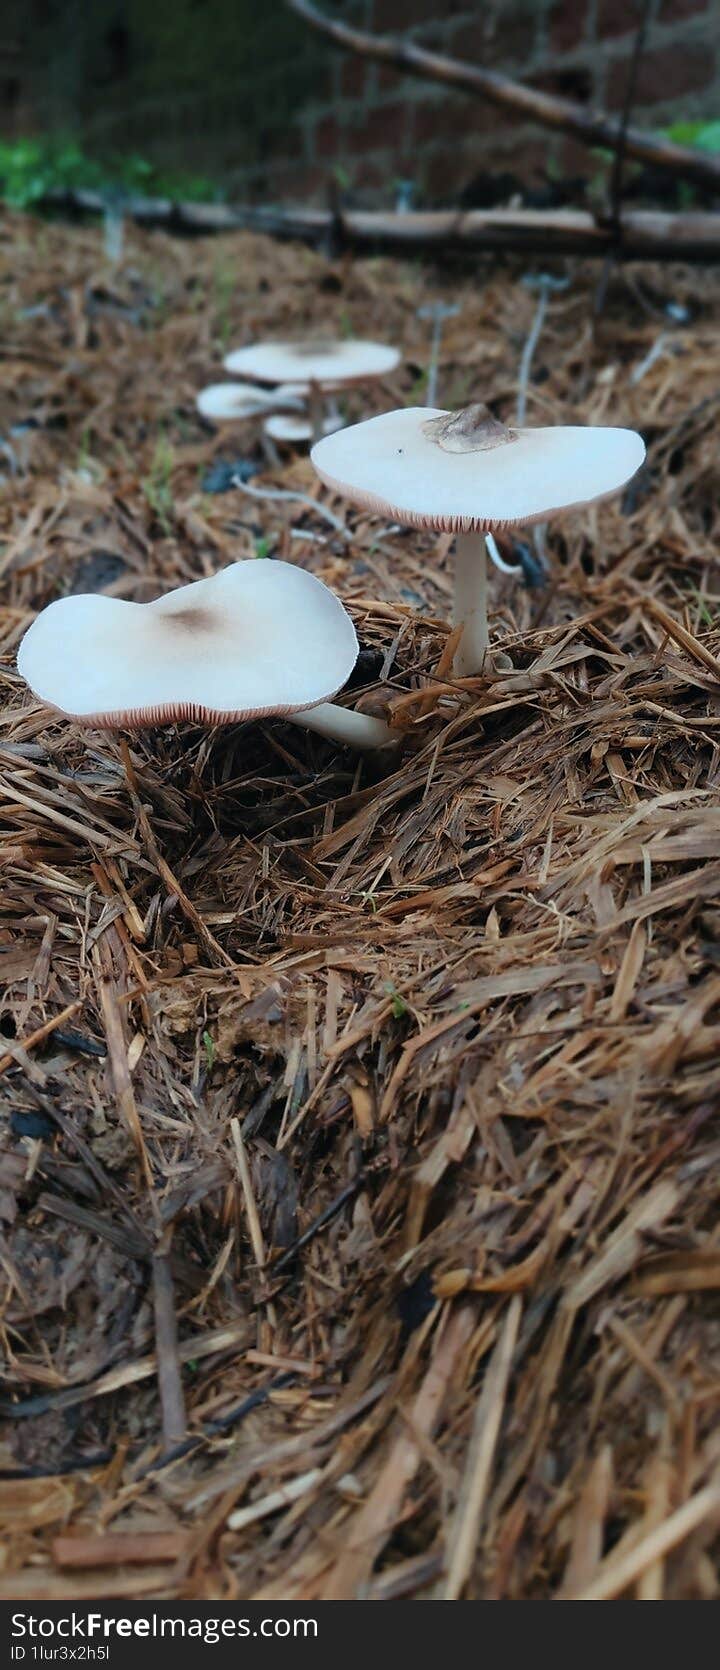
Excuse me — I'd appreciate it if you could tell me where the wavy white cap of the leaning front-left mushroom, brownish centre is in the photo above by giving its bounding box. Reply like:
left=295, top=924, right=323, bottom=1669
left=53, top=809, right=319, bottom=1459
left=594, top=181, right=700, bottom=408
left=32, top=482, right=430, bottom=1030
left=17, top=559, right=357, bottom=726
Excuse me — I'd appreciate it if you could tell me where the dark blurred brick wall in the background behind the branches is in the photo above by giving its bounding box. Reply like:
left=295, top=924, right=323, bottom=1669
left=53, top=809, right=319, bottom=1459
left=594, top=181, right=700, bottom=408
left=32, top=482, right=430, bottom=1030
left=0, top=0, right=720, bottom=204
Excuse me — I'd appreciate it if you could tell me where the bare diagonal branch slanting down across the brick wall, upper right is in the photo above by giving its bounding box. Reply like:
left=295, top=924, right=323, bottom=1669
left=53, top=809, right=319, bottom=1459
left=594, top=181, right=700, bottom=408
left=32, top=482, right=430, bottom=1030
left=286, top=0, right=720, bottom=192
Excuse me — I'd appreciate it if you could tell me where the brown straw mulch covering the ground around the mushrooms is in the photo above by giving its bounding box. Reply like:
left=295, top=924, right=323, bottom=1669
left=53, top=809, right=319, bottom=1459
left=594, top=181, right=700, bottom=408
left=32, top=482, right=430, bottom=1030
left=0, top=217, right=720, bottom=1600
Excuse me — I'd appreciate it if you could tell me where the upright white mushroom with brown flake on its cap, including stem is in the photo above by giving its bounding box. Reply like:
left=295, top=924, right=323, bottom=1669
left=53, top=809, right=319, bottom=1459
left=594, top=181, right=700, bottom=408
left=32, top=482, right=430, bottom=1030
left=311, top=404, right=645, bottom=678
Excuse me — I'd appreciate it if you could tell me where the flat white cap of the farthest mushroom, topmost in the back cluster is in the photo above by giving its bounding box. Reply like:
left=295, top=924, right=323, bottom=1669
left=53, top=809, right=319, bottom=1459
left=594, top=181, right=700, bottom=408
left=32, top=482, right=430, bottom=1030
left=226, top=337, right=399, bottom=387
